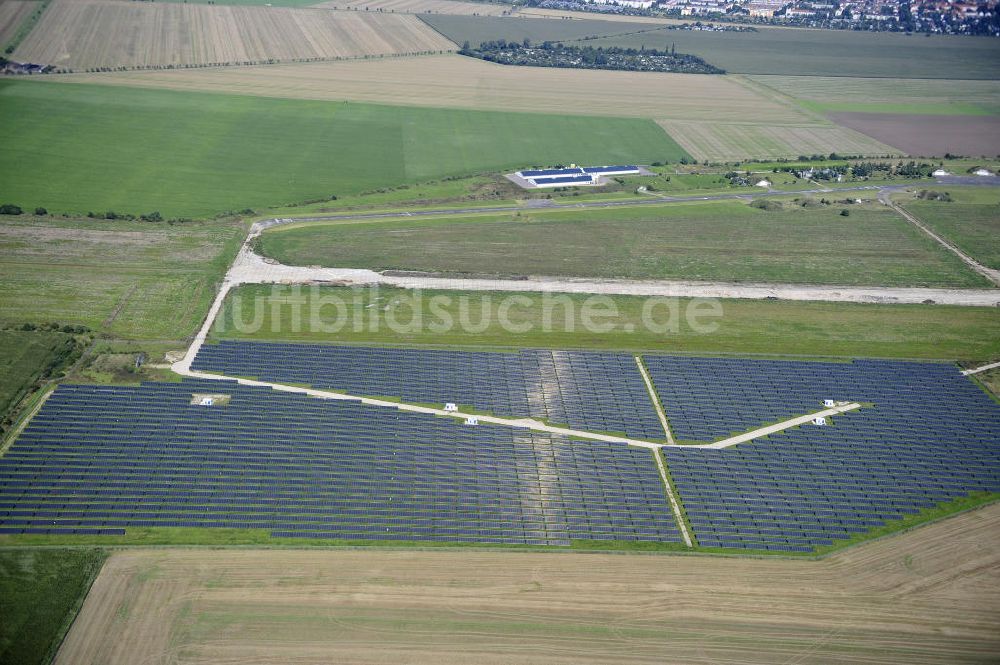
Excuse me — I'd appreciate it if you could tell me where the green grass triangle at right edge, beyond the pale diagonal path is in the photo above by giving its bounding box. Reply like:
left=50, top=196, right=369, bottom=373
left=903, top=187, right=1000, bottom=269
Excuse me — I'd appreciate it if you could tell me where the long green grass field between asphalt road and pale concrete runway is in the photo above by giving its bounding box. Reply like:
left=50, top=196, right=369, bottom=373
left=260, top=202, right=988, bottom=286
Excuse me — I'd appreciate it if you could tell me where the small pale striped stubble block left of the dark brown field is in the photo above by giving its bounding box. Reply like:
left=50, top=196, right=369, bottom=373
left=659, top=120, right=899, bottom=161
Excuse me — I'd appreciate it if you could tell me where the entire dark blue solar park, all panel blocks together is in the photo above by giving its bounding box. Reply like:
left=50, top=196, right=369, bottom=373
left=0, top=342, right=1000, bottom=553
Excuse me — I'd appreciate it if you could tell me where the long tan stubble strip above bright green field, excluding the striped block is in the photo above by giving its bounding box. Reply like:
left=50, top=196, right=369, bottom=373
left=51, top=53, right=816, bottom=123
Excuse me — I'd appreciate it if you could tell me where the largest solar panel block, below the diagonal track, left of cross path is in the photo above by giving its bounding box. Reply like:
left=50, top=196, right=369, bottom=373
left=0, top=380, right=680, bottom=545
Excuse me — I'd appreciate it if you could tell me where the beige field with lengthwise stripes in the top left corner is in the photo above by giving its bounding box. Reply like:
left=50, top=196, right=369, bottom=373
left=14, top=0, right=455, bottom=70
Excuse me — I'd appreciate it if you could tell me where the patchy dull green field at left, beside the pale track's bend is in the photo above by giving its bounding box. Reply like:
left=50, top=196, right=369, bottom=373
left=0, top=216, right=245, bottom=339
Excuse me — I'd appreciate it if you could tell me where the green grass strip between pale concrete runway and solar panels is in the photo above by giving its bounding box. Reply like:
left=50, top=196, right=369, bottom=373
left=212, top=285, right=1000, bottom=360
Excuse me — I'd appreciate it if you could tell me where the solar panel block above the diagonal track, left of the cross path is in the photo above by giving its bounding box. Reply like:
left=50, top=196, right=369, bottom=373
left=192, top=341, right=666, bottom=440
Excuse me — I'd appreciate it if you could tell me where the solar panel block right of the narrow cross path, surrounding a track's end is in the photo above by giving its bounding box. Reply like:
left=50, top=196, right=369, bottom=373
left=645, top=356, right=1000, bottom=551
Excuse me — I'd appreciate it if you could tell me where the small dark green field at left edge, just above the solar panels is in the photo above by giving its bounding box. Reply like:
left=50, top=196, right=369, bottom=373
left=0, top=330, right=76, bottom=430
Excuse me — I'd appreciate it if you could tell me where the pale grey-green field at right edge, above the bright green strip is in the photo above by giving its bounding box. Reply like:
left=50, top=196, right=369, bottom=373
left=749, top=76, right=1000, bottom=115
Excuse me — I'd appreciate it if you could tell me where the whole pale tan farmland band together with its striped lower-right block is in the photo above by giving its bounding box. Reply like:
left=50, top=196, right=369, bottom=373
left=50, top=55, right=899, bottom=160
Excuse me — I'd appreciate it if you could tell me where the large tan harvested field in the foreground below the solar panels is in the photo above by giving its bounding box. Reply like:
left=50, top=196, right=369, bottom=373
left=56, top=505, right=1000, bottom=665
